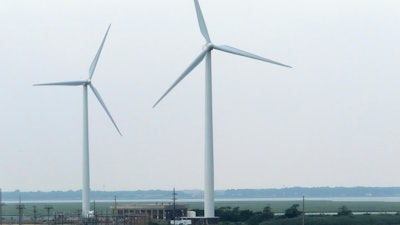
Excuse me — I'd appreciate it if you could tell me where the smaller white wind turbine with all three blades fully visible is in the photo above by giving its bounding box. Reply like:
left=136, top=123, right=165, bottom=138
left=34, top=24, right=122, bottom=218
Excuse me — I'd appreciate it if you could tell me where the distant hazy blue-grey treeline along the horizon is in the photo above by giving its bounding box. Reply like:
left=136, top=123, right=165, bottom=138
left=2, top=187, right=400, bottom=201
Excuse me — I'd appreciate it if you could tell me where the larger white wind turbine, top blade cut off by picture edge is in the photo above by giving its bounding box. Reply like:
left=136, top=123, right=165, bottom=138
left=153, top=0, right=291, bottom=218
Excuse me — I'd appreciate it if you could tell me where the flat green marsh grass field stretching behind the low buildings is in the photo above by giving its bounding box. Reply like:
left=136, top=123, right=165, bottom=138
left=2, top=200, right=400, bottom=216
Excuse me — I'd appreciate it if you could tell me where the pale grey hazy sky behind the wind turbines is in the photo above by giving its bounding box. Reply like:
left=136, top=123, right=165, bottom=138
left=0, top=0, right=400, bottom=191
